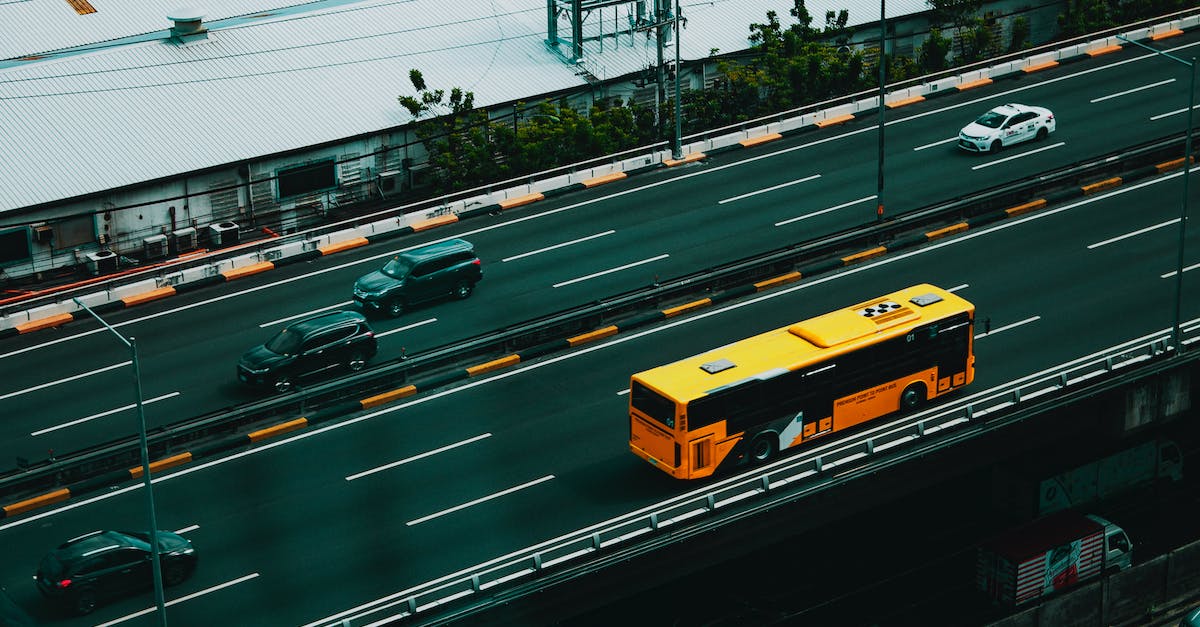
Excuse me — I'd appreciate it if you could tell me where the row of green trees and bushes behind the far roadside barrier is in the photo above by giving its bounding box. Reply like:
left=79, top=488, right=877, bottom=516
left=397, top=0, right=1194, bottom=192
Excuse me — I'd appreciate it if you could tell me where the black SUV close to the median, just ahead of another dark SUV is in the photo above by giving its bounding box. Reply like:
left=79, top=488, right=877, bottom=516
left=238, top=311, right=377, bottom=392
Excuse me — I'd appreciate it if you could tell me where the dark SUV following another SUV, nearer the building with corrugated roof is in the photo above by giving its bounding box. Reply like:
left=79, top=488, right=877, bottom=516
left=354, top=239, right=484, bottom=317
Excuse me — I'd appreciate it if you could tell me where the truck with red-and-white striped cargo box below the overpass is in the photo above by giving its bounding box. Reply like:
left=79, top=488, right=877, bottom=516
left=976, top=512, right=1133, bottom=607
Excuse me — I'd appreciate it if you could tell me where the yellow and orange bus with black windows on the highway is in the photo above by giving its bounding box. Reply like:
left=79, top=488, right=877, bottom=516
left=629, top=283, right=974, bottom=479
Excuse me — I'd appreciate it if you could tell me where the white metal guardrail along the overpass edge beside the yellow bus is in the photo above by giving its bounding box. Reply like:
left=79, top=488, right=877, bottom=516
left=333, top=320, right=1200, bottom=627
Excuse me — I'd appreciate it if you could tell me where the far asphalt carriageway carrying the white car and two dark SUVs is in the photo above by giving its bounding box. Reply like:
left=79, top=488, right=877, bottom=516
left=9, top=36, right=1195, bottom=460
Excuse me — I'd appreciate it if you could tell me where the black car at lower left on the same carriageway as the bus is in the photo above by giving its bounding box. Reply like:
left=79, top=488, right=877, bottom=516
left=35, top=531, right=197, bottom=614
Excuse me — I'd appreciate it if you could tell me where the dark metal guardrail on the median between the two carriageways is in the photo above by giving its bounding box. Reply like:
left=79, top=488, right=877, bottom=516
left=0, top=129, right=1183, bottom=498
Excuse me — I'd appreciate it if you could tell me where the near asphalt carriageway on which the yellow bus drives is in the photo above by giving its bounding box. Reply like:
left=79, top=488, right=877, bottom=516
left=0, top=159, right=1200, bottom=625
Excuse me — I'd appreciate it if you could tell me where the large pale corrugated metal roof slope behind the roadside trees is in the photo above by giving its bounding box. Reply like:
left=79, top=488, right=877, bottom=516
left=0, top=0, right=919, bottom=211
